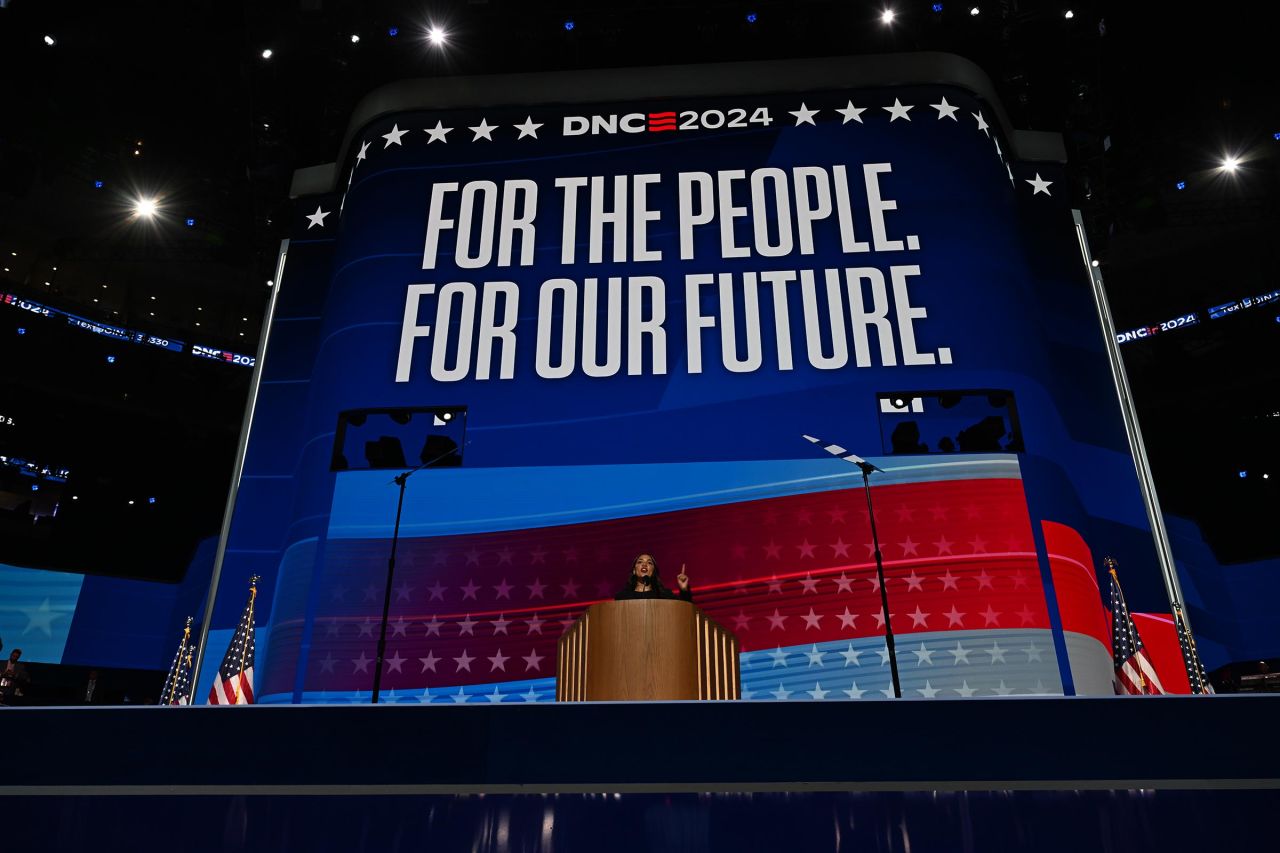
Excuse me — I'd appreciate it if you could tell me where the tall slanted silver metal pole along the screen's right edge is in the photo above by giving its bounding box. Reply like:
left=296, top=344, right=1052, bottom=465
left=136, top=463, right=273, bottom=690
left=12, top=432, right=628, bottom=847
left=1071, top=210, right=1192, bottom=633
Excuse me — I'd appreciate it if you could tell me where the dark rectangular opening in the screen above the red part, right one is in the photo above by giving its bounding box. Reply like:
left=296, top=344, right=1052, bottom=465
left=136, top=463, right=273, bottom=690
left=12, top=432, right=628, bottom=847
left=876, top=388, right=1025, bottom=455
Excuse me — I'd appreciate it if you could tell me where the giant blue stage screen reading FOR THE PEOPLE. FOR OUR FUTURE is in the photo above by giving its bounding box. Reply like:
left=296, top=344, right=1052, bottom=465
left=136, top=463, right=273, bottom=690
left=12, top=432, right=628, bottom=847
left=212, top=58, right=1185, bottom=703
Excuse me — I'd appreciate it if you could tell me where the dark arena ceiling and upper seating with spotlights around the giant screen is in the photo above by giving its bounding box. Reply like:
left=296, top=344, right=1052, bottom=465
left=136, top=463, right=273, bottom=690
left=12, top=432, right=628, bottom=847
left=0, top=0, right=1280, bottom=580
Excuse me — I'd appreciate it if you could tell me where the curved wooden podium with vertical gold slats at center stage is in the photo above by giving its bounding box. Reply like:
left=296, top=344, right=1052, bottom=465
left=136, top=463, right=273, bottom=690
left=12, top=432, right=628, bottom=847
left=556, top=598, right=740, bottom=702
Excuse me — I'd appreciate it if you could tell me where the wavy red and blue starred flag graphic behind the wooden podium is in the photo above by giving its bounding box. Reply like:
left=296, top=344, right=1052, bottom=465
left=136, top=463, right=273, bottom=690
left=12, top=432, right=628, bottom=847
left=277, top=459, right=1062, bottom=703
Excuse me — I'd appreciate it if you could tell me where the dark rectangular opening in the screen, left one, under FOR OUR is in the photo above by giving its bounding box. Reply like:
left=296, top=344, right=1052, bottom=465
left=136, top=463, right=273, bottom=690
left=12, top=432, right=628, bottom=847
left=330, top=406, right=467, bottom=471
